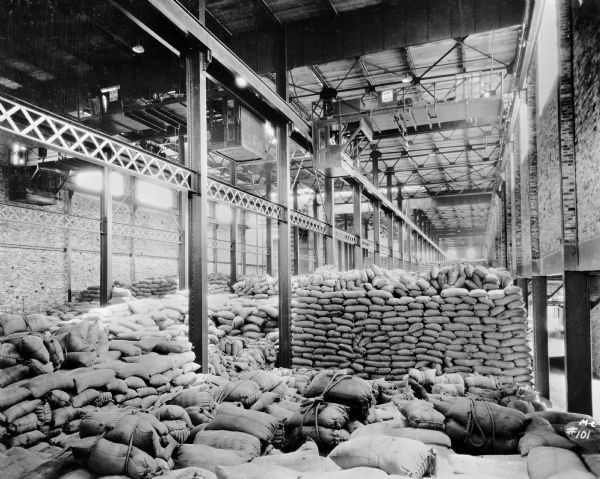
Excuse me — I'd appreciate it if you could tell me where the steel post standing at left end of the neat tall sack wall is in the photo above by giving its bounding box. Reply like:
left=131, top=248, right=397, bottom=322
left=275, top=29, right=292, bottom=368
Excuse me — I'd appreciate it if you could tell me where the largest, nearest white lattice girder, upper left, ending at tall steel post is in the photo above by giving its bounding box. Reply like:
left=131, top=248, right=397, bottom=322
left=0, top=96, right=192, bottom=190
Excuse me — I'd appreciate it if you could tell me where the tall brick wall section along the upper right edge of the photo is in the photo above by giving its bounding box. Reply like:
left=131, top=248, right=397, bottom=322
left=573, top=1, right=600, bottom=241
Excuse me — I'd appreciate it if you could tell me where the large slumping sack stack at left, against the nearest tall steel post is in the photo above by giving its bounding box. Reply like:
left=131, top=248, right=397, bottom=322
left=0, top=297, right=205, bottom=454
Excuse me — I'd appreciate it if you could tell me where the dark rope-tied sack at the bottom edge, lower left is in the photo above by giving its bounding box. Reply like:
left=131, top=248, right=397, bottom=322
left=71, top=437, right=161, bottom=479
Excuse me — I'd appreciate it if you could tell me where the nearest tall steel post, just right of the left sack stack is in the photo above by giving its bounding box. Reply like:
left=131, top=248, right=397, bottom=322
left=186, top=7, right=208, bottom=373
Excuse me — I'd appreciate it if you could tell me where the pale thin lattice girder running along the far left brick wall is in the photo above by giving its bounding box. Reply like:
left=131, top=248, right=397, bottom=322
left=0, top=204, right=180, bottom=243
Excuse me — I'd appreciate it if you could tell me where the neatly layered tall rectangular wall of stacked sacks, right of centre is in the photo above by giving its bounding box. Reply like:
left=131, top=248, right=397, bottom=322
left=292, top=265, right=532, bottom=384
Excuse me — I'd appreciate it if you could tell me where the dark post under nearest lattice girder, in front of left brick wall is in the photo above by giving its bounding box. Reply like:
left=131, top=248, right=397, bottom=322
left=100, top=166, right=113, bottom=306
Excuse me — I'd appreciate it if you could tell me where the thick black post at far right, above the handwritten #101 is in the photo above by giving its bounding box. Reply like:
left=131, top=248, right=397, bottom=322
left=564, top=271, right=593, bottom=416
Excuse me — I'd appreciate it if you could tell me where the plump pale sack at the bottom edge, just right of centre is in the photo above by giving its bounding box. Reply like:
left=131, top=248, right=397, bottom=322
left=329, top=436, right=435, bottom=479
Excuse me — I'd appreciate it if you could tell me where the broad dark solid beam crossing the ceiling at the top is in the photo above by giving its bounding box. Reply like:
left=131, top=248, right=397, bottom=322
left=230, top=0, right=526, bottom=74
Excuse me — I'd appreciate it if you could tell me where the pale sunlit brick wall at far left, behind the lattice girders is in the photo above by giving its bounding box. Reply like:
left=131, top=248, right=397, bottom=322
left=0, top=163, right=179, bottom=312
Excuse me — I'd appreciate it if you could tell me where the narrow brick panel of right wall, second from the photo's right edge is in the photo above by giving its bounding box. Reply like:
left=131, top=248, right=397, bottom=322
left=537, top=85, right=562, bottom=258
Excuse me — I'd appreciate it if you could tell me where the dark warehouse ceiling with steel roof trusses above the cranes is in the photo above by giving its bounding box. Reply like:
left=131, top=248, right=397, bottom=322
left=0, top=0, right=525, bottom=255
